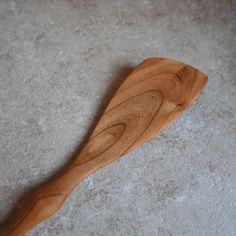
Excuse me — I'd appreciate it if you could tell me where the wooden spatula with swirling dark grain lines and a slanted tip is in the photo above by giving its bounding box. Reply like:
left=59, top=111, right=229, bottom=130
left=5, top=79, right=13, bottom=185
left=0, top=58, right=207, bottom=236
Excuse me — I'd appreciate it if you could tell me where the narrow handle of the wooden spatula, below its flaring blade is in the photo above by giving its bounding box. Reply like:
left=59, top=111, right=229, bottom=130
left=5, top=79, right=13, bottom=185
left=0, top=160, right=85, bottom=236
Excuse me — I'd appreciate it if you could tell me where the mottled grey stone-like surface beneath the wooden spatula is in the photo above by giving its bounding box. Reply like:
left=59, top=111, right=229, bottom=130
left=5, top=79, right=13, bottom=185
left=0, top=0, right=236, bottom=236
